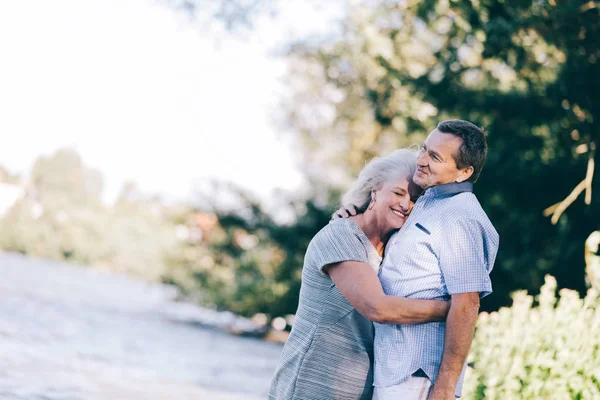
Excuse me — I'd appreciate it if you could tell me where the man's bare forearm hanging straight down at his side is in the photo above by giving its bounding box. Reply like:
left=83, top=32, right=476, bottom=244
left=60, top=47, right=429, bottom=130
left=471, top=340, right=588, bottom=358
left=429, top=292, right=479, bottom=400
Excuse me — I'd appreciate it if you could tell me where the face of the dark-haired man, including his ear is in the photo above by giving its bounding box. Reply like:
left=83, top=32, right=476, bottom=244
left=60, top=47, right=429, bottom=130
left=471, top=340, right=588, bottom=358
left=413, top=129, right=473, bottom=189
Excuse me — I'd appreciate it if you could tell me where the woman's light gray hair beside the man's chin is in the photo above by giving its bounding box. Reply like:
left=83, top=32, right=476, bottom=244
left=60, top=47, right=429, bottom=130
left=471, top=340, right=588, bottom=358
left=341, top=148, right=418, bottom=214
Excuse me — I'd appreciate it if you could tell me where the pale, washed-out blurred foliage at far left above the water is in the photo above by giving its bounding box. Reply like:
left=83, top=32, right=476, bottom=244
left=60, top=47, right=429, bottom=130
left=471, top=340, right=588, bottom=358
left=0, top=149, right=178, bottom=280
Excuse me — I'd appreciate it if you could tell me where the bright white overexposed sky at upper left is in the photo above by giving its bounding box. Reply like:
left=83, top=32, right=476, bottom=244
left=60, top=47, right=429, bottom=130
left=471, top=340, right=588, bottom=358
left=0, top=0, right=342, bottom=205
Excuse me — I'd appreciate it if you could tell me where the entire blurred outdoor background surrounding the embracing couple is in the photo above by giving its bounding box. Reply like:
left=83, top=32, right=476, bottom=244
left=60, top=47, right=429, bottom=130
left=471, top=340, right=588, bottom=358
left=0, top=0, right=600, bottom=399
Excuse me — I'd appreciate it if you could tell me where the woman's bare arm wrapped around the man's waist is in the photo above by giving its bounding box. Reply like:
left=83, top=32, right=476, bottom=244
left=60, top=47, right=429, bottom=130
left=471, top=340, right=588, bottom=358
left=325, top=261, right=448, bottom=324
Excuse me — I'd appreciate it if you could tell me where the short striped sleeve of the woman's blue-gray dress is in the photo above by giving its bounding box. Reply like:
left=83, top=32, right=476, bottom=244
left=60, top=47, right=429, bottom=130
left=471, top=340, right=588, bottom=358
left=307, top=220, right=369, bottom=275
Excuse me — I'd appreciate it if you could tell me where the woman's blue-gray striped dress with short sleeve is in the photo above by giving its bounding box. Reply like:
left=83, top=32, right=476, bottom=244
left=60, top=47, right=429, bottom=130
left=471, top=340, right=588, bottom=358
left=269, top=219, right=381, bottom=400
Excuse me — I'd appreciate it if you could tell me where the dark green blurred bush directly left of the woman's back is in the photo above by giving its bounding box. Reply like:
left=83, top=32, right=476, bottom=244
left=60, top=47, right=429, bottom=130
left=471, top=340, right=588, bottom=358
left=169, top=184, right=331, bottom=317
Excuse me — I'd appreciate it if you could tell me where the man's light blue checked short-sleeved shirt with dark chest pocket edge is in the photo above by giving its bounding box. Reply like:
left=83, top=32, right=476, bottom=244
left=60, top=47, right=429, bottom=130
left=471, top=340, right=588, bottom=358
left=374, top=182, right=499, bottom=397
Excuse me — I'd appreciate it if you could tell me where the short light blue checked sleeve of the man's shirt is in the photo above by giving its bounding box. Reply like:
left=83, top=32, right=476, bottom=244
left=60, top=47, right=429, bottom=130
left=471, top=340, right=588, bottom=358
left=440, top=217, right=495, bottom=298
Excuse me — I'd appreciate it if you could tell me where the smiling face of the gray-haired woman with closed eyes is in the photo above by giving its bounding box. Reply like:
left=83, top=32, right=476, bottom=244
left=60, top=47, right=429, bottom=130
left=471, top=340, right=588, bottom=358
left=371, top=177, right=414, bottom=231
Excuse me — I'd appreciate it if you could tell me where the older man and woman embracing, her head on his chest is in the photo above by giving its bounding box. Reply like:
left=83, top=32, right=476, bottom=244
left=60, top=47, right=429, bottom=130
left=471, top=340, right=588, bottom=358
left=269, top=120, right=499, bottom=400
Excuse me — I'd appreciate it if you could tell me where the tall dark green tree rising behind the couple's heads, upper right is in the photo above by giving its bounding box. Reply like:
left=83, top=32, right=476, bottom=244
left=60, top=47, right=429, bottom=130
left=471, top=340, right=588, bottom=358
left=287, top=0, right=600, bottom=309
